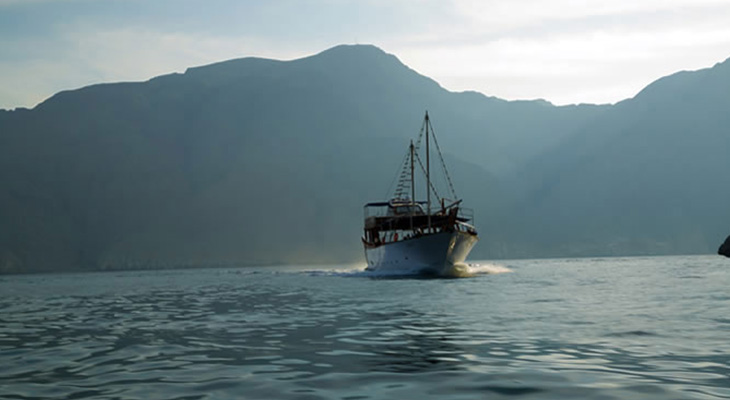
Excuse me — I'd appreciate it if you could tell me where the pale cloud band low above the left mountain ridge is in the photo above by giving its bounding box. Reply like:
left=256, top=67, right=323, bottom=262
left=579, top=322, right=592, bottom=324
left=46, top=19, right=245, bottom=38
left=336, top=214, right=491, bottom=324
left=0, top=26, right=332, bottom=108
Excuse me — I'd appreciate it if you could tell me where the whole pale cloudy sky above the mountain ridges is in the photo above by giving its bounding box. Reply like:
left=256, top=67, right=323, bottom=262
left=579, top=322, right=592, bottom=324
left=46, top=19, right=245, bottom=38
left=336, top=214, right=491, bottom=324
left=0, top=0, right=730, bottom=108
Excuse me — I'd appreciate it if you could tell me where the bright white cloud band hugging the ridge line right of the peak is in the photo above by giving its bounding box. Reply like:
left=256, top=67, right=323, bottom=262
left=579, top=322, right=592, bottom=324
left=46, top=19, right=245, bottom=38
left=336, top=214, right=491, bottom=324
left=395, top=24, right=730, bottom=104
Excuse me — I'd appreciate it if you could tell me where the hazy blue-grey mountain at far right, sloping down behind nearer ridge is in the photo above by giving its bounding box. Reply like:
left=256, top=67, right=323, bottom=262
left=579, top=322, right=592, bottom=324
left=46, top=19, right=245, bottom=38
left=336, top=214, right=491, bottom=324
left=500, top=57, right=730, bottom=255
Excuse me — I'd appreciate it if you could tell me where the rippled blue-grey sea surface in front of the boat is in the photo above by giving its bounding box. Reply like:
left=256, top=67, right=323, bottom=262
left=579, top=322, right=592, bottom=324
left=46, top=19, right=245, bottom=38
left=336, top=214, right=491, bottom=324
left=0, top=256, right=730, bottom=400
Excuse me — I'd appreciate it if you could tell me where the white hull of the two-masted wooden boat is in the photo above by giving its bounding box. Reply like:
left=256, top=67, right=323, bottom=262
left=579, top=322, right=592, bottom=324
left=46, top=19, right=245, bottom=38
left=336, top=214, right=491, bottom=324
left=365, top=231, right=479, bottom=275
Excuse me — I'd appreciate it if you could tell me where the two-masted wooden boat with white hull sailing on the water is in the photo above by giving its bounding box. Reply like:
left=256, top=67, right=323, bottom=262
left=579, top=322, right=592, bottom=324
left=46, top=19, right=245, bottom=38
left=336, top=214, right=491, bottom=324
left=362, top=112, right=479, bottom=275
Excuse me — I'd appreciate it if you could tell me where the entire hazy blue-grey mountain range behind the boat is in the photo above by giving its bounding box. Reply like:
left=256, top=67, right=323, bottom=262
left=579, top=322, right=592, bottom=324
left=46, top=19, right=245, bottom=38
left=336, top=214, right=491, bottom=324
left=0, top=46, right=730, bottom=271
